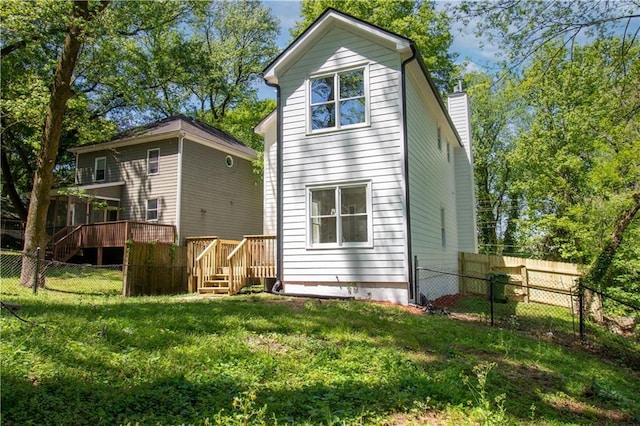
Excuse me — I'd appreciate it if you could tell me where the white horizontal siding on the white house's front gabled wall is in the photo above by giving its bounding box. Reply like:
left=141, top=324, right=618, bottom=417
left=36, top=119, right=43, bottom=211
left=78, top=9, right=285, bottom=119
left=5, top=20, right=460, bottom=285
left=280, top=28, right=408, bottom=286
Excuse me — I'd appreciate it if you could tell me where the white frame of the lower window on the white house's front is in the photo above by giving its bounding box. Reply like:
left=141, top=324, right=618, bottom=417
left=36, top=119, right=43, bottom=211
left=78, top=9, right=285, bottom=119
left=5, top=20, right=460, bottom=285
left=306, top=181, right=373, bottom=249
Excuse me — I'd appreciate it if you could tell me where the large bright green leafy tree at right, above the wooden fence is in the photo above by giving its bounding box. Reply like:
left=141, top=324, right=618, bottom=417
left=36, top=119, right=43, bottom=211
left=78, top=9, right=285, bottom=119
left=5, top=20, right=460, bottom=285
left=514, top=37, right=640, bottom=290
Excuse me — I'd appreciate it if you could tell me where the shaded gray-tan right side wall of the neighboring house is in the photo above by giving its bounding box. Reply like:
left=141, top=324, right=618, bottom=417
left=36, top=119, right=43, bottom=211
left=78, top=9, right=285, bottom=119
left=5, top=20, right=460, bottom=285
left=180, top=139, right=262, bottom=239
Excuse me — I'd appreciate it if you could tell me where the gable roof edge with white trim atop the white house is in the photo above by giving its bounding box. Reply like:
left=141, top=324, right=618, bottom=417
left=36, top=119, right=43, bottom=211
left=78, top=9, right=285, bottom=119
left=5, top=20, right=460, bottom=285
left=262, top=8, right=463, bottom=146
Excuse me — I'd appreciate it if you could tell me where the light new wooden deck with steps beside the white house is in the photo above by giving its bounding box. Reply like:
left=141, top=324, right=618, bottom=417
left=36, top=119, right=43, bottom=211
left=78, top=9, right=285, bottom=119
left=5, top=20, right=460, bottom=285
left=187, top=235, right=276, bottom=294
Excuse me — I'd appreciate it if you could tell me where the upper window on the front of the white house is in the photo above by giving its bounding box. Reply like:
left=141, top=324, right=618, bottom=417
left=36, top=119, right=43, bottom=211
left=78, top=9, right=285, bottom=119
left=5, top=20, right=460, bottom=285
left=309, top=68, right=367, bottom=131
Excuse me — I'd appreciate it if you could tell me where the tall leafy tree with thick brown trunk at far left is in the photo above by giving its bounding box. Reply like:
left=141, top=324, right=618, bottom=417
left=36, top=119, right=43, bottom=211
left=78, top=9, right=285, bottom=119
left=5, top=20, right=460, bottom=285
left=0, top=0, right=195, bottom=285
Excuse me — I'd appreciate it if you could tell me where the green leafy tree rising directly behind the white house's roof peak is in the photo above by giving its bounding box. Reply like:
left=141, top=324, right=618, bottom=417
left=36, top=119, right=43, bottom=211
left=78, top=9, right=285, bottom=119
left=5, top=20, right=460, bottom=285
left=291, top=0, right=457, bottom=93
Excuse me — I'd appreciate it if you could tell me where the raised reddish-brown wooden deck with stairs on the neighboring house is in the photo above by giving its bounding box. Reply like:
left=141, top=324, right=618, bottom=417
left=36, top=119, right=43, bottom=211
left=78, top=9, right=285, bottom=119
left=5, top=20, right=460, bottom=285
left=52, top=221, right=176, bottom=264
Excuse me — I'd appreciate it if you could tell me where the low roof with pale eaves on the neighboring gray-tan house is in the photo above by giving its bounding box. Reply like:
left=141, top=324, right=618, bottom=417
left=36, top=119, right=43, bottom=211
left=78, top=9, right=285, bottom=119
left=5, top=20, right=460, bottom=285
left=69, top=114, right=257, bottom=160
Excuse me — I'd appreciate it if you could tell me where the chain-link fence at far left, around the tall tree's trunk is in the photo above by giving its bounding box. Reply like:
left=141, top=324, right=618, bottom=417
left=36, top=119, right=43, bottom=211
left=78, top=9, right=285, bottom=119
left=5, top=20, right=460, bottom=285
left=0, top=250, right=122, bottom=297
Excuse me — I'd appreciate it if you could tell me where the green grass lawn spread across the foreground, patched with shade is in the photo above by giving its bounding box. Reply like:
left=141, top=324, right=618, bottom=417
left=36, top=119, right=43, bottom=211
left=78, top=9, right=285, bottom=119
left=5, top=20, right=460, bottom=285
left=0, top=293, right=640, bottom=425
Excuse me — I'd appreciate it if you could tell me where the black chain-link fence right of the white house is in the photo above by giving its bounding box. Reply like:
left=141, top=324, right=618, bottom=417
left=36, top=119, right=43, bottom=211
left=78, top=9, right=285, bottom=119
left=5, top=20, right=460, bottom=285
left=415, top=267, right=640, bottom=341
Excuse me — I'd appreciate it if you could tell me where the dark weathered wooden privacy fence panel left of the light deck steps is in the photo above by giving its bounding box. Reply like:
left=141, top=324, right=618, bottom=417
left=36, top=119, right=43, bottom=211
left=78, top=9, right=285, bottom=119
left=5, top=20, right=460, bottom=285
left=122, top=243, right=188, bottom=297
